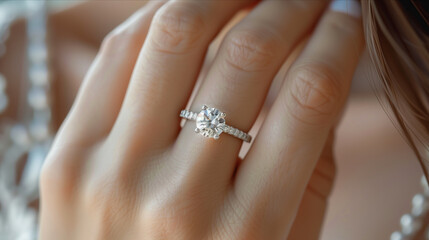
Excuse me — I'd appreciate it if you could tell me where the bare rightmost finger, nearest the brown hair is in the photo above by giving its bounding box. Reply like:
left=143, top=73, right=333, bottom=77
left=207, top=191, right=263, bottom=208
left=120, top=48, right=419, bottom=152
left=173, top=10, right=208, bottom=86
left=234, top=1, right=364, bottom=239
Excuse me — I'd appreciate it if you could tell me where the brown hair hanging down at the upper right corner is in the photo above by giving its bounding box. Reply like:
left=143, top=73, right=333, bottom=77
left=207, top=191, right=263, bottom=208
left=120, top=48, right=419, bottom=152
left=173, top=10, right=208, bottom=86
left=362, top=0, right=429, bottom=179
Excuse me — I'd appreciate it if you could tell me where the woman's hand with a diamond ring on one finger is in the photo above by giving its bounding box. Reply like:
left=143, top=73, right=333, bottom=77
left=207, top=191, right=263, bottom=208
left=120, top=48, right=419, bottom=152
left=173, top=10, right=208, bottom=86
left=40, top=0, right=363, bottom=240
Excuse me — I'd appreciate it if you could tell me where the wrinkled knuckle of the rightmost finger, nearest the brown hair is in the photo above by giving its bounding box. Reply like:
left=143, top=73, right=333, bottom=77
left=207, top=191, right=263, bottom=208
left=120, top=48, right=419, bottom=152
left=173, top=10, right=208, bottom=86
left=285, top=63, right=342, bottom=124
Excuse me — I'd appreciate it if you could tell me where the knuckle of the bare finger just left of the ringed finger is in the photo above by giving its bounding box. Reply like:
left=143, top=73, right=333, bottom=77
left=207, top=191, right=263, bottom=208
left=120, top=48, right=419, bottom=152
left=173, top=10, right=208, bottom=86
left=151, top=2, right=204, bottom=53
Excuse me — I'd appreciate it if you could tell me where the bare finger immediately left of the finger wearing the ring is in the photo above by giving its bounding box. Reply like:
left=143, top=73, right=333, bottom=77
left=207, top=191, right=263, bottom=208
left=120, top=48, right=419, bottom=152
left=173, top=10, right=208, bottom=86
left=112, top=0, right=251, bottom=148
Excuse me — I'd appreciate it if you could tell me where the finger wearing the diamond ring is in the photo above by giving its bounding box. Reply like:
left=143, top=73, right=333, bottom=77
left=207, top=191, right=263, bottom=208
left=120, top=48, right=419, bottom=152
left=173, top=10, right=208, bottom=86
left=177, top=1, right=325, bottom=186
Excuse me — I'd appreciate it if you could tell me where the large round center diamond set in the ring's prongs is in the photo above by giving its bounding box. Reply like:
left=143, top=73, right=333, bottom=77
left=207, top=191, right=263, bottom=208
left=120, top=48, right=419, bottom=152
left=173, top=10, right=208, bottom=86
left=195, top=106, right=225, bottom=139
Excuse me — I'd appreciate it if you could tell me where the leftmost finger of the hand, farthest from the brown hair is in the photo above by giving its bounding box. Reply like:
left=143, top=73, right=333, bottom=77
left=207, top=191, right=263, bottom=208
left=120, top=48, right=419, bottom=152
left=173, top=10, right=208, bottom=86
left=57, top=1, right=163, bottom=144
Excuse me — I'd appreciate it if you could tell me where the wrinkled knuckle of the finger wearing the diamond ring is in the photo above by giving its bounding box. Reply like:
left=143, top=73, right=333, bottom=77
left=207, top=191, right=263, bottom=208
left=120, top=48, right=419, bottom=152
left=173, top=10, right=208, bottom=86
left=225, top=27, right=279, bottom=72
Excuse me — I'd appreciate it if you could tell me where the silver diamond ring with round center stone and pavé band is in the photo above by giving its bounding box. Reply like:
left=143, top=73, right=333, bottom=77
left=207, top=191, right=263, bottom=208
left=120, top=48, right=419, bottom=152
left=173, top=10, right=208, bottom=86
left=180, top=105, right=252, bottom=142
